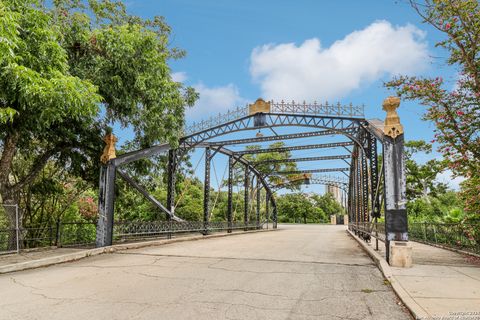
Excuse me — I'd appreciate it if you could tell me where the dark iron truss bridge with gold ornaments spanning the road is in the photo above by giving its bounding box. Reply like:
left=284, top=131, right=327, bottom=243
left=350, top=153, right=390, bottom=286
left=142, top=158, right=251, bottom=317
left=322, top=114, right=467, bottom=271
left=97, top=98, right=408, bottom=264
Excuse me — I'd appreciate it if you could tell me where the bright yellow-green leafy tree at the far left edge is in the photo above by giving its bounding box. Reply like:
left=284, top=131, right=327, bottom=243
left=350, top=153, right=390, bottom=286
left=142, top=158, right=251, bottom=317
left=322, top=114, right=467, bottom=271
left=0, top=0, right=101, bottom=225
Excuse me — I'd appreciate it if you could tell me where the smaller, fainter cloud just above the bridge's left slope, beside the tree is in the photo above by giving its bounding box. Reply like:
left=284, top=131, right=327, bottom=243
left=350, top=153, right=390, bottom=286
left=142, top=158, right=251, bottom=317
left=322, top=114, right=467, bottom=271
left=187, top=83, right=246, bottom=120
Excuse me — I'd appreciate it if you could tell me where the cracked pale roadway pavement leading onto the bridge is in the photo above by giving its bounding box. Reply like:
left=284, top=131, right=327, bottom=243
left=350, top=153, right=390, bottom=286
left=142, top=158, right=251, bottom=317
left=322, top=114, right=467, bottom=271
left=0, top=225, right=411, bottom=320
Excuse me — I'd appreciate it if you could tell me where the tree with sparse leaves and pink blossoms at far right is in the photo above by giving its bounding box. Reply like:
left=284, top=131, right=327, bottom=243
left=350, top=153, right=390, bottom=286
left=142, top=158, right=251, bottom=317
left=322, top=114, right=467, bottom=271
left=386, top=0, right=480, bottom=212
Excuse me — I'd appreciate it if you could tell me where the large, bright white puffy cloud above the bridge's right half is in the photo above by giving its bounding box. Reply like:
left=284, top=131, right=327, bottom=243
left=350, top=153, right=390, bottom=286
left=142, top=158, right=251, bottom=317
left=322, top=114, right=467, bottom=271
left=250, top=21, right=428, bottom=101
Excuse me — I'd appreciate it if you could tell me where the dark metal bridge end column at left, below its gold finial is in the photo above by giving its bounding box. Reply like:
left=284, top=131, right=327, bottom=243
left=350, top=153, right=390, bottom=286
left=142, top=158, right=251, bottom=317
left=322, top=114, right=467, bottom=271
left=95, top=162, right=116, bottom=248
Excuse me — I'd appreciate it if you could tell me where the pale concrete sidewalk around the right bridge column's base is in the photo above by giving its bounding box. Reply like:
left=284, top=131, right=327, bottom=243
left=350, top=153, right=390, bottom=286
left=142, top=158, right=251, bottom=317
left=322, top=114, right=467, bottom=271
left=348, top=231, right=480, bottom=320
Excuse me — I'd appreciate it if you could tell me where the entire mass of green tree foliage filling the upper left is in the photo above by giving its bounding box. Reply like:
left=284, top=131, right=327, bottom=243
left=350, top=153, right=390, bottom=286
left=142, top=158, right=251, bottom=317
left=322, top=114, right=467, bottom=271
left=0, top=0, right=197, bottom=232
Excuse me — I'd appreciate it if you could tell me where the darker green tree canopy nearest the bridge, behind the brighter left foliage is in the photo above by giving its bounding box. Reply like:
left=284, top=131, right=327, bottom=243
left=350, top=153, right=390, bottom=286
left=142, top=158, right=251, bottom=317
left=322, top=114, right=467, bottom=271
left=55, top=1, right=198, bottom=148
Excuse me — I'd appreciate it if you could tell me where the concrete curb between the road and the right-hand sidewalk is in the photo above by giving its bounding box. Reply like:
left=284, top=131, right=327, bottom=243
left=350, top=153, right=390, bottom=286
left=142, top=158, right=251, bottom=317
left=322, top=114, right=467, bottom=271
left=347, top=230, right=431, bottom=319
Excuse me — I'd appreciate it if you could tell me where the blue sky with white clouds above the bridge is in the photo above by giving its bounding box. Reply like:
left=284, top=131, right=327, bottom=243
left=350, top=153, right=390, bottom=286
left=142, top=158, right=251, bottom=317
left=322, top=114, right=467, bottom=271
left=121, top=0, right=464, bottom=192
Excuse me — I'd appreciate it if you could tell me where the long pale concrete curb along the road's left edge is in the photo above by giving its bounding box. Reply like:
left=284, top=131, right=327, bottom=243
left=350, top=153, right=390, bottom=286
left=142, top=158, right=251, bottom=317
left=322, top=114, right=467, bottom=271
left=0, top=229, right=278, bottom=274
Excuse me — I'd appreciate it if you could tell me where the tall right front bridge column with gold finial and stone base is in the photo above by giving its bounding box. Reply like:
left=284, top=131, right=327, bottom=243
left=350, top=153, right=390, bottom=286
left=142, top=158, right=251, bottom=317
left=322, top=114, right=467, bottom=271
left=383, top=97, right=412, bottom=267
